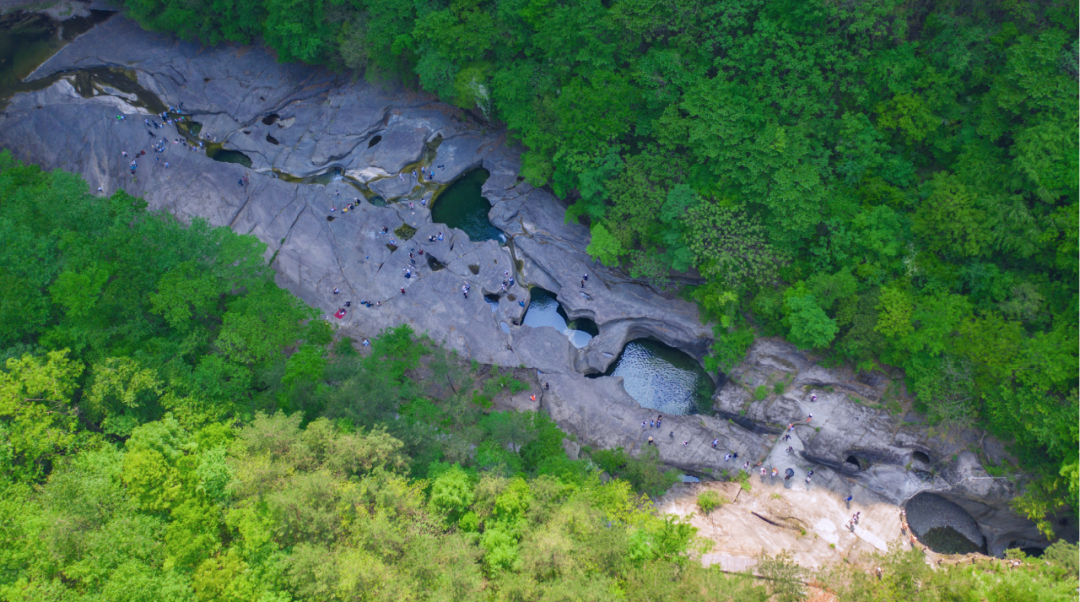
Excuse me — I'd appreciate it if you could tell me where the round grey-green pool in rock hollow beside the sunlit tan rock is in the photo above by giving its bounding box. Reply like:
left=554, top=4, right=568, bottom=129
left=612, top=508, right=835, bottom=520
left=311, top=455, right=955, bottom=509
left=904, top=493, right=986, bottom=554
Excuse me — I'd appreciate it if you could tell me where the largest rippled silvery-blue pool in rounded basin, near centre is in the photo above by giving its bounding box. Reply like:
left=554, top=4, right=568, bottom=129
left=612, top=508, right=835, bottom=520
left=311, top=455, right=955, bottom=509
left=590, top=338, right=716, bottom=415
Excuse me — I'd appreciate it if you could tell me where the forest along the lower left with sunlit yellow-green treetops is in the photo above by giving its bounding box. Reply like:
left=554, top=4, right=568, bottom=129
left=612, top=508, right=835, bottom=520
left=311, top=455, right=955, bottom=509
left=0, top=151, right=1080, bottom=602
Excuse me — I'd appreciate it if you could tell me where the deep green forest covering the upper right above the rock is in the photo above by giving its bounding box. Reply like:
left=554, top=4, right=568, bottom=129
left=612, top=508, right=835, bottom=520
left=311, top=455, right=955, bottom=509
left=116, top=0, right=1080, bottom=534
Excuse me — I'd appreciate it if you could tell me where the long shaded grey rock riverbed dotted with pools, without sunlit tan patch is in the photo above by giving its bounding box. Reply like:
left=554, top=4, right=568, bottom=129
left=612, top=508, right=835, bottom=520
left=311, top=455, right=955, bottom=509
left=0, top=10, right=1071, bottom=553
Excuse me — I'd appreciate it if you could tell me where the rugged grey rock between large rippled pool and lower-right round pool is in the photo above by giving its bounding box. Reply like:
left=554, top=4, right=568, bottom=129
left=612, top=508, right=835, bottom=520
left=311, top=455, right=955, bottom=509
left=714, top=339, right=1080, bottom=556
